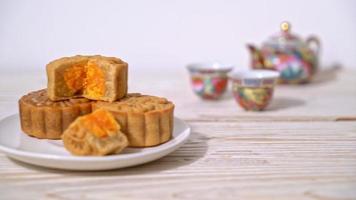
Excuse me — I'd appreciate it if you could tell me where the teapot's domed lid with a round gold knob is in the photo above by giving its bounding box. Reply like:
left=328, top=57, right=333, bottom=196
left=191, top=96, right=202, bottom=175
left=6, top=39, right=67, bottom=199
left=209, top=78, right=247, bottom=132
left=263, top=22, right=305, bottom=51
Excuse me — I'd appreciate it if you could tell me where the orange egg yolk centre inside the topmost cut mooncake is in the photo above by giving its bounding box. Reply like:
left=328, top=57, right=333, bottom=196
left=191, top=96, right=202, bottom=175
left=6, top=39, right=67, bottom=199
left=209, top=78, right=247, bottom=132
left=64, top=60, right=105, bottom=98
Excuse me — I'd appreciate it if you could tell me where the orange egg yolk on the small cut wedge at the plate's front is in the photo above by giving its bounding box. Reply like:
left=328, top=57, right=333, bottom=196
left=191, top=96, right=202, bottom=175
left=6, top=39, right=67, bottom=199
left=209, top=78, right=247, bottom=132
left=82, top=109, right=120, bottom=138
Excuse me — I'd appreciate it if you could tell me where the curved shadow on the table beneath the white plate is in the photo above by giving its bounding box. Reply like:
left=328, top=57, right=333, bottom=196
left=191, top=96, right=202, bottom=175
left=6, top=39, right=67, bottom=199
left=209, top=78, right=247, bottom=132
left=9, top=132, right=208, bottom=174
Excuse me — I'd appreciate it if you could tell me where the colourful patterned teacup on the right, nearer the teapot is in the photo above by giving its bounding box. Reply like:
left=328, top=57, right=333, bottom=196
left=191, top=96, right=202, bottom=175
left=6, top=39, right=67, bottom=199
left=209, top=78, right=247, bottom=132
left=229, top=70, right=279, bottom=111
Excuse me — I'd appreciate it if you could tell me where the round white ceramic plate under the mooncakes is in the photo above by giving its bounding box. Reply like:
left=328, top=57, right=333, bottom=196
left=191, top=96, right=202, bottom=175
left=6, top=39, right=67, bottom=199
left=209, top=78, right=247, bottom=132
left=0, top=114, right=190, bottom=170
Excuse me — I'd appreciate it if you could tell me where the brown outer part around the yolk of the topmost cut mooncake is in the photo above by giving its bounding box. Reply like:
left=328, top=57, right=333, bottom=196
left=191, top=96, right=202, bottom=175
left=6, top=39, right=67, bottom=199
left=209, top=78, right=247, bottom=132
left=46, top=55, right=128, bottom=102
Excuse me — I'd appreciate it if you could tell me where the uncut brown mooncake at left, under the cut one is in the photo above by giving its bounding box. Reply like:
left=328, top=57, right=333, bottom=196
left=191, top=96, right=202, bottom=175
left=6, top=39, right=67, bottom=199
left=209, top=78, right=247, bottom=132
left=19, top=89, right=91, bottom=139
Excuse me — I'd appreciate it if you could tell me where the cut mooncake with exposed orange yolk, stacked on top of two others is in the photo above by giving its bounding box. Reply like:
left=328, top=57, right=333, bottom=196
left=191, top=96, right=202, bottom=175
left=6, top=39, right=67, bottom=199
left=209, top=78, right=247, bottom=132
left=46, top=55, right=128, bottom=102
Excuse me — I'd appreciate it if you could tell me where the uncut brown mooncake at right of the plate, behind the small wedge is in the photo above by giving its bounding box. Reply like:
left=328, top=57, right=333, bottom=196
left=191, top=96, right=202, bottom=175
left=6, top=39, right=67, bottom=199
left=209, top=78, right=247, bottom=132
left=93, top=94, right=174, bottom=147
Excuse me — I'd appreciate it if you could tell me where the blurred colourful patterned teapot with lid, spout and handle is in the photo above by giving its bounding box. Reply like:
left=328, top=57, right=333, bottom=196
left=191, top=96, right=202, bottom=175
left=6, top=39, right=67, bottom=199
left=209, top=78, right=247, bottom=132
left=247, top=22, right=320, bottom=84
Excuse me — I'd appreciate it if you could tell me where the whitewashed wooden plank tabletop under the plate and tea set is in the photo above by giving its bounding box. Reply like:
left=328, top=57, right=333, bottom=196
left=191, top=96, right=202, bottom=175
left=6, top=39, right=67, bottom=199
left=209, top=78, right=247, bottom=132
left=0, top=68, right=356, bottom=200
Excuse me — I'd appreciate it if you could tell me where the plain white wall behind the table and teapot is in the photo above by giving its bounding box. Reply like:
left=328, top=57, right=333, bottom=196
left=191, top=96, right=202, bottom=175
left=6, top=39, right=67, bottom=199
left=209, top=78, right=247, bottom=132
left=0, top=0, right=356, bottom=72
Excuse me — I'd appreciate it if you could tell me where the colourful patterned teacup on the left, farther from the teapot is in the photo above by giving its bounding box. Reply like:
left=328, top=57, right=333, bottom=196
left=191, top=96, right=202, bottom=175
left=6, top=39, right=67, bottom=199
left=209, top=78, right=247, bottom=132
left=187, top=62, right=233, bottom=100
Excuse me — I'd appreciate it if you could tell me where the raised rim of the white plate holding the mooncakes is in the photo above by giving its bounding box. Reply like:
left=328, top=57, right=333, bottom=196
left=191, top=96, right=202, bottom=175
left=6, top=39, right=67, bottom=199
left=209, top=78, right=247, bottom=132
left=0, top=113, right=191, bottom=162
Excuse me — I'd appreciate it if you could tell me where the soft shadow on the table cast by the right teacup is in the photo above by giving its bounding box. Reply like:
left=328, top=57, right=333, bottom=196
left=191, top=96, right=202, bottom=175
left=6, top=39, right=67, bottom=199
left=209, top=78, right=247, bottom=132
left=266, top=97, right=305, bottom=111
